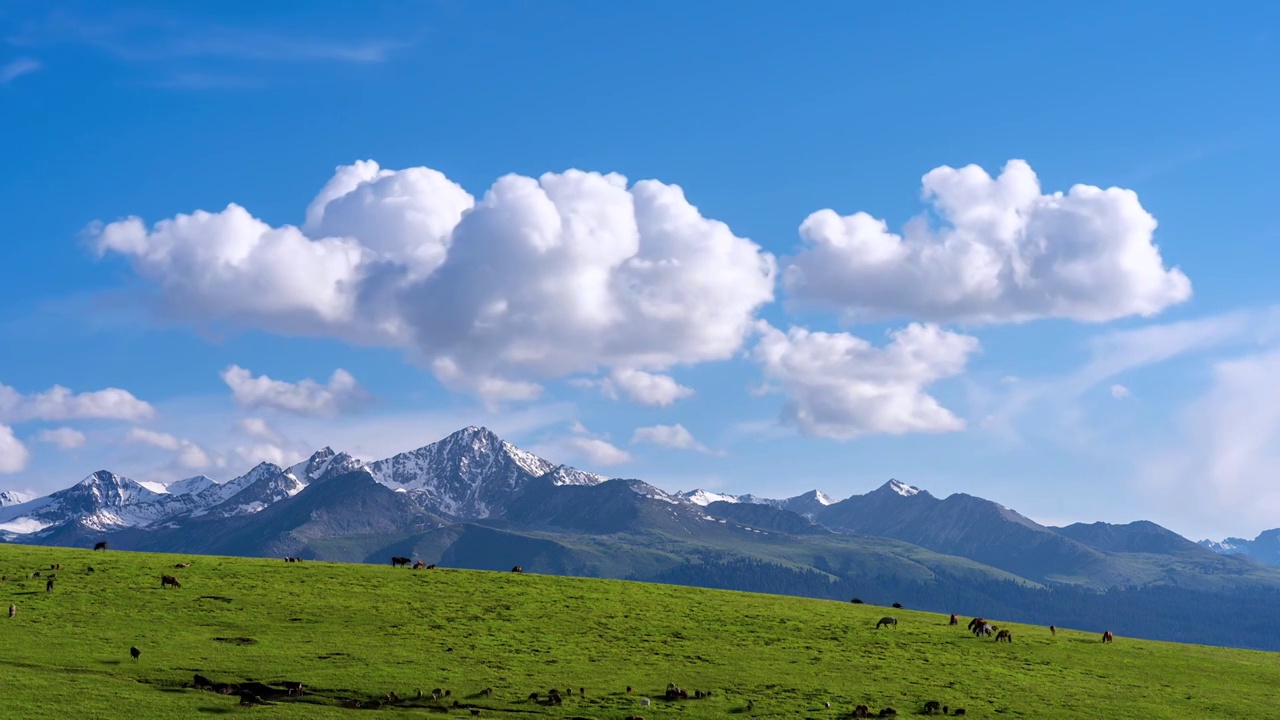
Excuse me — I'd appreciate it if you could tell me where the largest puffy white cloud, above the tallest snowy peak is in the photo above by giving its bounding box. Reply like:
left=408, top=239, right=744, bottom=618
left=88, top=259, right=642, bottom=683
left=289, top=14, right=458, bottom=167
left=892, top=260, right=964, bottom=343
left=92, top=161, right=776, bottom=400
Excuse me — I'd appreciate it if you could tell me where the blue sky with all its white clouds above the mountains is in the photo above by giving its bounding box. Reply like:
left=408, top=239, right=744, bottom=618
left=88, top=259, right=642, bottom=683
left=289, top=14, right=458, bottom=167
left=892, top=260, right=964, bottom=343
left=0, top=0, right=1280, bottom=539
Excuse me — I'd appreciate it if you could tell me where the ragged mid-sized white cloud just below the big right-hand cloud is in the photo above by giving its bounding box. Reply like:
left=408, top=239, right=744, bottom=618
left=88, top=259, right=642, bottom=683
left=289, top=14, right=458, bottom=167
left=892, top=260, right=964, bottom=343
left=751, top=320, right=979, bottom=439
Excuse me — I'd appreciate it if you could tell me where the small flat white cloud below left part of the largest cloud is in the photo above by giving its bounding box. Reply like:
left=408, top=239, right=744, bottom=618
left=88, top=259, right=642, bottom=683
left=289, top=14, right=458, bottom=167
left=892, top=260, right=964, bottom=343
left=221, top=365, right=369, bottom=416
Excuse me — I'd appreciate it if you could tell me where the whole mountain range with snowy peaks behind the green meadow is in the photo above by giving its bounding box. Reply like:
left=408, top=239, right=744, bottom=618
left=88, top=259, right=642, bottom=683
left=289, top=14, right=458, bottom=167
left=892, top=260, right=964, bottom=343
left=0, top=427, right=1280, bottom=650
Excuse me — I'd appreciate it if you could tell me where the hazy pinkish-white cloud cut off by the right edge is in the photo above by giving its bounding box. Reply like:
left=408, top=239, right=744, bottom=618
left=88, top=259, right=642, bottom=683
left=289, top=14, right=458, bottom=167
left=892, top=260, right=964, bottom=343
left=1139, top=351, right=1280, bottom=534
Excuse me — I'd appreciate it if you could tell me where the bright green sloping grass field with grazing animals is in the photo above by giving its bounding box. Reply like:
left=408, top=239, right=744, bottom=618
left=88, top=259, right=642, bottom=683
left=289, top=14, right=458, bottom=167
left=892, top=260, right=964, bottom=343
left=0, top=546, right=1280, bottom=720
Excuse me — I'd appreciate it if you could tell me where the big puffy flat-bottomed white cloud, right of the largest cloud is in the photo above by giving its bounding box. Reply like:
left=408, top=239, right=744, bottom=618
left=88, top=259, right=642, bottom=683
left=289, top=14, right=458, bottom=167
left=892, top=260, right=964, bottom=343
left=783, top=160, right=1192, bottom=323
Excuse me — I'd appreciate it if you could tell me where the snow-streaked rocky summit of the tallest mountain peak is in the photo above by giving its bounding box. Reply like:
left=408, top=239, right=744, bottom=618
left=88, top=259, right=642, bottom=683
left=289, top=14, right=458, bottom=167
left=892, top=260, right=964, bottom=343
left=365, top=425, right=604, bottom=519
